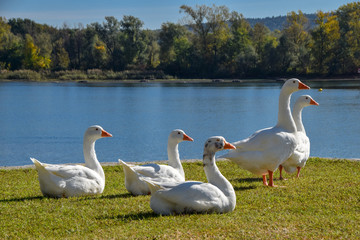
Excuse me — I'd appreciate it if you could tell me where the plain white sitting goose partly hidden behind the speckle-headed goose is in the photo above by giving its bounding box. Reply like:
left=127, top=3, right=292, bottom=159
left=119, top=129, right=194, bottom=195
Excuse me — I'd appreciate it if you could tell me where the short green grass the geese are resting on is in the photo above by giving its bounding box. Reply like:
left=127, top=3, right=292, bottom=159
left=0, top=158, right=360, bottom=239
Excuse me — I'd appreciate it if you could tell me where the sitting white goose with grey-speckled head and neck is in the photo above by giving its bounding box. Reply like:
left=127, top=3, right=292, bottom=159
left=143, top=137, right=236, bottom=215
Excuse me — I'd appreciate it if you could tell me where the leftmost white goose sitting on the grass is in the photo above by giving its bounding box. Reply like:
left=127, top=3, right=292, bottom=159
left=30, top=125, right=112, bottom=197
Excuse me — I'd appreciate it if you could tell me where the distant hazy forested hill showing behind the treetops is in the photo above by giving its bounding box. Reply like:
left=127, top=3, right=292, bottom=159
left=245, top=14, right=316, bottom=31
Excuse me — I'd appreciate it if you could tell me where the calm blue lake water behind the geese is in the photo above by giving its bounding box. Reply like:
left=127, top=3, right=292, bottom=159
left=0, top=81, right=360, bottom=166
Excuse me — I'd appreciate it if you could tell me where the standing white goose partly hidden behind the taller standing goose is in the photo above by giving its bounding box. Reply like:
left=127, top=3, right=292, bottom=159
left=279, top=95, right=319, bottom=180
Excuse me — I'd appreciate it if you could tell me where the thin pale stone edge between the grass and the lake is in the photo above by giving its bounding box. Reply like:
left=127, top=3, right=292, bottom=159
left=0, top=157, right=360, bottom=170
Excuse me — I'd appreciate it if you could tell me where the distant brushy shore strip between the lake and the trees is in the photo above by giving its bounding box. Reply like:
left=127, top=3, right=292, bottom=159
left=0, top=70, right=360, bottom=83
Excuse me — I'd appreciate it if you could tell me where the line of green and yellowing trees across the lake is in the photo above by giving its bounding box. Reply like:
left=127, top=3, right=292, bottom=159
left=0, top=2, right=360, bottom=78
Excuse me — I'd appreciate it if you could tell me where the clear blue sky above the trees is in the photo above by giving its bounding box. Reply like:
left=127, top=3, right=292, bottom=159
left=0, top=0, right=354, bottom=29
